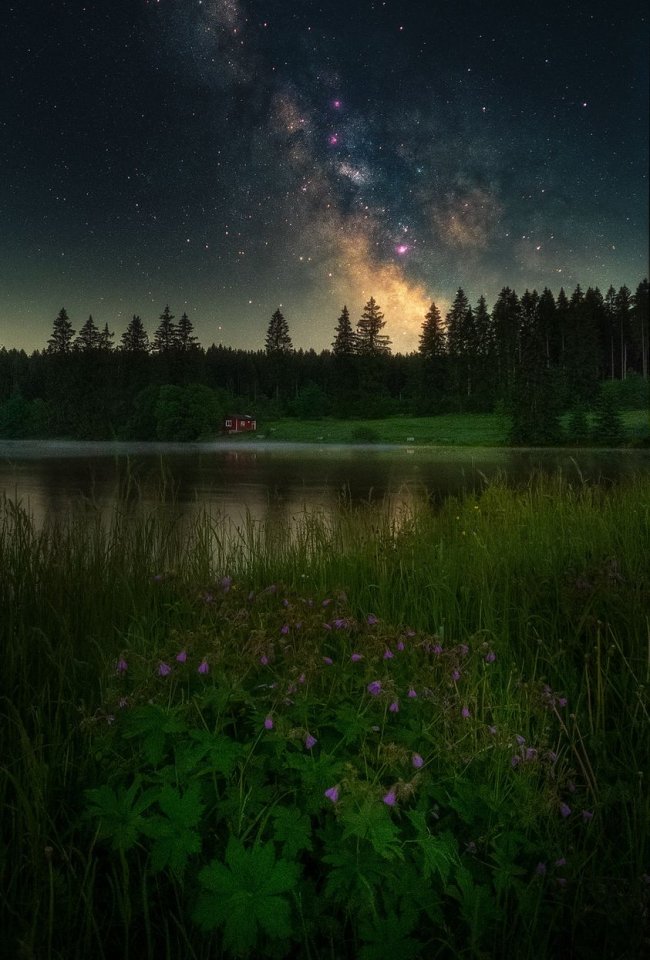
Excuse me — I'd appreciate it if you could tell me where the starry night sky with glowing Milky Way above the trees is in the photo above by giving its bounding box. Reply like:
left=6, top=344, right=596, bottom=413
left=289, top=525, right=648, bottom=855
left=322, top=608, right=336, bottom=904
left=0, top=0, right=649, bottom=352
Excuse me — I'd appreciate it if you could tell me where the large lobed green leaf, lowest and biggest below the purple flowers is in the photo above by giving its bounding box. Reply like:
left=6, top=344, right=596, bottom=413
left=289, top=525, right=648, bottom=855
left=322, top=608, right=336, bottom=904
left=194, top=837, right=298, bottom=954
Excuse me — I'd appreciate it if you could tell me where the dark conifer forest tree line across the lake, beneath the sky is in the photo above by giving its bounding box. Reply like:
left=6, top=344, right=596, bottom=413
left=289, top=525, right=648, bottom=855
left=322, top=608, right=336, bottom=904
left=0, top=279, right=649, bottom=443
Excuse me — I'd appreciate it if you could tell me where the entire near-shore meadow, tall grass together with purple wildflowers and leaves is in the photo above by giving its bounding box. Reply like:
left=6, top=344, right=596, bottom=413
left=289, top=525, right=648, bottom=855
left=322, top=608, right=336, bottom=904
left=0, top=478, right=650, bottom=960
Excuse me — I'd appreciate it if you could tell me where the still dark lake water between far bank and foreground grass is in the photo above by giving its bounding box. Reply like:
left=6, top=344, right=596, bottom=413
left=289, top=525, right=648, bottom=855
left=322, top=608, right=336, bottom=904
left=0, top=440, right=650, bottom=525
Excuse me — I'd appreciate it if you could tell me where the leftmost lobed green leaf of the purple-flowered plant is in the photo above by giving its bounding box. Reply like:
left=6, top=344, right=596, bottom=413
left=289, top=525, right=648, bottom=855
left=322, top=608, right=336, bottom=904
left=85, top=779, right=156, bottom=852
